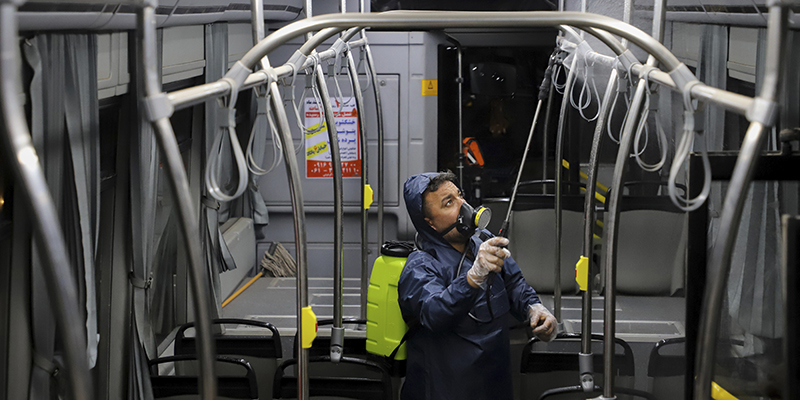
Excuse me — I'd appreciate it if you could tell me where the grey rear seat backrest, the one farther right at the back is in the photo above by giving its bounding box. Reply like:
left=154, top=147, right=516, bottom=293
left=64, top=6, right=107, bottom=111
left=617, top=210, right=687, bottom=296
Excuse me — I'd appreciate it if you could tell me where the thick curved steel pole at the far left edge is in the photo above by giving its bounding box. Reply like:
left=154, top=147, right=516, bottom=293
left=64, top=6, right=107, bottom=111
left=0, top=0, right=94, bottom=399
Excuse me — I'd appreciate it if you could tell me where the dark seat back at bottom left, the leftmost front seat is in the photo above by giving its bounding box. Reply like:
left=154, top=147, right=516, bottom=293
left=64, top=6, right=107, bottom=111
left=147, top=355, right=258, bottom=400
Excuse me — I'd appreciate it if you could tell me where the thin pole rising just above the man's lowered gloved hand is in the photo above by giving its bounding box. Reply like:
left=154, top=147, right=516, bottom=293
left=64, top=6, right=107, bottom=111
left=553, top=54, right=578, bottom=324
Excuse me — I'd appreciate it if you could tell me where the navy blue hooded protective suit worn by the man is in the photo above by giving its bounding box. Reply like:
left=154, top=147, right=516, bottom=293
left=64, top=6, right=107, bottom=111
left=398, top=173, right=540, bottom=400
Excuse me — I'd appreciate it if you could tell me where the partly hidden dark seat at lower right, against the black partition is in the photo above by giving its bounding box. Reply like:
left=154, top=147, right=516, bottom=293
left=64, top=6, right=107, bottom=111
left=647, top=337, right=686, bottom=400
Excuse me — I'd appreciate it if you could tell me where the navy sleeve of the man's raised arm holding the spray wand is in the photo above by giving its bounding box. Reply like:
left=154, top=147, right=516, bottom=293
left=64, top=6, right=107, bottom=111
left=398, top=255, right=481, bottom=331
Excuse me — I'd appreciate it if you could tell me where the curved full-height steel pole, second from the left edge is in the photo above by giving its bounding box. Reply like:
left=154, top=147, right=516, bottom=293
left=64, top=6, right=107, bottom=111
left=136, top=4, right=217, bottom=400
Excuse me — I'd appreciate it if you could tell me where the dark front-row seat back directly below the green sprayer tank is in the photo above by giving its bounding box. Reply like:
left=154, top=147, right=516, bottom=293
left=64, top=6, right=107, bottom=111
left=272, top=356, right=393, bottom=400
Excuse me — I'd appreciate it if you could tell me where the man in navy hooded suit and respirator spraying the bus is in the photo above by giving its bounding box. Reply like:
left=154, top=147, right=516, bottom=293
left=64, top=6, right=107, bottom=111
left=398, top=172, right=556, bottom=400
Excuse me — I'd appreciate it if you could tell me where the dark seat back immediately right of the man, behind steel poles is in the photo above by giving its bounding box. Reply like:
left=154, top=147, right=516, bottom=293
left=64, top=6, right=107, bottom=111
left=519, top=333, right=635, bottom=400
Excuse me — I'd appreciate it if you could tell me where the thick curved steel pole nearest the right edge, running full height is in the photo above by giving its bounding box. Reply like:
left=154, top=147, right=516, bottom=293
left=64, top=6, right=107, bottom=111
left=694, top=1, right=789, bottom=399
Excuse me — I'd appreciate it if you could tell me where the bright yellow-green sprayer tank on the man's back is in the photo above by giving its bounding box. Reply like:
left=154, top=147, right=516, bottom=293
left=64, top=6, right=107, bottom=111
left=367, top=241, right=414, bottom=361
